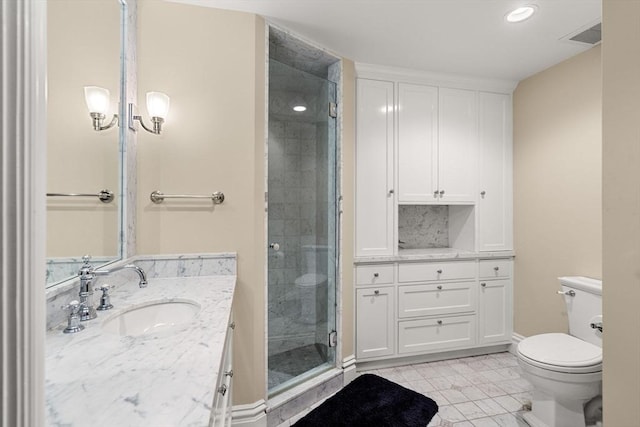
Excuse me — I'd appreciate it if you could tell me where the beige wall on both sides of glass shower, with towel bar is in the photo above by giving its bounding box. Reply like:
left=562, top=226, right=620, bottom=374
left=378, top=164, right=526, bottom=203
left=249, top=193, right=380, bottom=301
left=137, top=0, right=355, bottom=405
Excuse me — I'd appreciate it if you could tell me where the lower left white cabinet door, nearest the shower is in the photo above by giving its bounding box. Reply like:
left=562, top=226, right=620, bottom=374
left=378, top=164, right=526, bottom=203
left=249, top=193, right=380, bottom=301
left=356, top=286, right=395, bottom=359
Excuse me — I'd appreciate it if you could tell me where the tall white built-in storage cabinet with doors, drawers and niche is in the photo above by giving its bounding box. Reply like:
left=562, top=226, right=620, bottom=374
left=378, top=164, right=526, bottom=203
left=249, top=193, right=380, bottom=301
left=355, top=66, right=515, bottom=367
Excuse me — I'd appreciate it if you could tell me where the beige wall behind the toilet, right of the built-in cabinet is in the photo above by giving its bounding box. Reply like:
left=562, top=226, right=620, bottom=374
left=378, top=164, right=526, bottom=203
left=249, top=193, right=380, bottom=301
left=513, top=46, right=602, bottom=336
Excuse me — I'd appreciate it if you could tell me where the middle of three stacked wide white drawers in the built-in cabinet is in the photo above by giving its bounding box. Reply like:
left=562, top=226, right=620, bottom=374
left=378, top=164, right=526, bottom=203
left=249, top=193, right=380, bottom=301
left=398, top=282, right=477, bottom=318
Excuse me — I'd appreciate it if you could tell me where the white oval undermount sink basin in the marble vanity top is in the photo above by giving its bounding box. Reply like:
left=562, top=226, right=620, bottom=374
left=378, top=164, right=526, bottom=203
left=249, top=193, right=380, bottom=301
left=102, top=300, right=200, bottom=336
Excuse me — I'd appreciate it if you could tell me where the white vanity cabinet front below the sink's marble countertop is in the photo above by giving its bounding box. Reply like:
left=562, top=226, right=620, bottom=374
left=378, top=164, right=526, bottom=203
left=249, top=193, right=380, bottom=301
left=209, top=321, right=235, bottom=427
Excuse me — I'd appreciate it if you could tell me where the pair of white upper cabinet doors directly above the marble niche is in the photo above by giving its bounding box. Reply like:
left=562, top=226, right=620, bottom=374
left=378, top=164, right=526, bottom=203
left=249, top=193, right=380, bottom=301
left=398, top=83, right=478, bottom=204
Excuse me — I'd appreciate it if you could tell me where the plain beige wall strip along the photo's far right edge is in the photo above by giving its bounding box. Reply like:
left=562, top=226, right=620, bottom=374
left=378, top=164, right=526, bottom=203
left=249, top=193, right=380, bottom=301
left=602, top=0, right=640, bottom=427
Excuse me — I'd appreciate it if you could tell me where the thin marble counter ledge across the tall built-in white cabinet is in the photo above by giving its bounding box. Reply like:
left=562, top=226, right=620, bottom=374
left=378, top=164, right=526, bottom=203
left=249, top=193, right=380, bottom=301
left=353, top=248, right=515, bottom=265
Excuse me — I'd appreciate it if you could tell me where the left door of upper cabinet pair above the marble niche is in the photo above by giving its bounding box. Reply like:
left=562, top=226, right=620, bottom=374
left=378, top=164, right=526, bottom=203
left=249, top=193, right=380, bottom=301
left=398, top=83, right=438, bottom=203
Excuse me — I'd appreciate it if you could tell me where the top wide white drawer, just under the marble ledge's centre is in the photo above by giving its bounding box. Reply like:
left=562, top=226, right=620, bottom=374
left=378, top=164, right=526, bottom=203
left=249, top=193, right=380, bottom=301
left=398, top=261, right=477, bottom=282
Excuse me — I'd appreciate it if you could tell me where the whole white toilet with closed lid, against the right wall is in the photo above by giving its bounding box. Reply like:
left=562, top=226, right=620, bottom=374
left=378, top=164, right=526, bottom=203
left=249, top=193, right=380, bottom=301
left=518, top=277, right=602, bottom=427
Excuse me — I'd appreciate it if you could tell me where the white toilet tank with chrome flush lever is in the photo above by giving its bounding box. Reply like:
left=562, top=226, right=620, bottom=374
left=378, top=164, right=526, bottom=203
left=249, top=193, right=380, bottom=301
left=559, top=276, right=602, bottom=347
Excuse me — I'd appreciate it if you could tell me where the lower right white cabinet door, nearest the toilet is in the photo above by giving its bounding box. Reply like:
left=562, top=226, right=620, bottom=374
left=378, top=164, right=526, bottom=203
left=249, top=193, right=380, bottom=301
left=478, top=279, right=513, bottom=344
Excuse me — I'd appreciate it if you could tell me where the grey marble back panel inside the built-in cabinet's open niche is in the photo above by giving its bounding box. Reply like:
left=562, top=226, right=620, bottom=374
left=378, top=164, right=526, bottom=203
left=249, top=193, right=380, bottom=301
left=398, top=205, right=449, bottom=249
